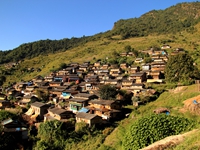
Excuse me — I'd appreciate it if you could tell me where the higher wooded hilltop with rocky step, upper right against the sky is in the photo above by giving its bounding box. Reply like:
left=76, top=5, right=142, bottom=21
left=111, top=2, right=200, bottom=39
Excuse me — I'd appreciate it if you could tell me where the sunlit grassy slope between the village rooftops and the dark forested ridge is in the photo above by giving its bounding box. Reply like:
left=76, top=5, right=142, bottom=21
left=3, top=24, right=200, bottom=85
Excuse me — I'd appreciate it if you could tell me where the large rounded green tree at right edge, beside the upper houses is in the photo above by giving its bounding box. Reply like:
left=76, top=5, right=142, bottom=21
left=165, top=53, right=200, bottom=84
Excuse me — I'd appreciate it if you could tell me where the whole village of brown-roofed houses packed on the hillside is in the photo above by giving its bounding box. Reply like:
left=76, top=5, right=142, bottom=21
left=0, top=45, right=184, bottom=141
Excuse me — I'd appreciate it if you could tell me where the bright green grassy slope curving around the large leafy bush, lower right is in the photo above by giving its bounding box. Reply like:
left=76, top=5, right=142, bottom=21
left=104, top=85, right=200, bottom=150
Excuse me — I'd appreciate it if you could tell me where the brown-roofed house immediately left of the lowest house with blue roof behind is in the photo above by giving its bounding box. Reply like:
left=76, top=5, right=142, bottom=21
left=44, top=107, right=74, bottom=121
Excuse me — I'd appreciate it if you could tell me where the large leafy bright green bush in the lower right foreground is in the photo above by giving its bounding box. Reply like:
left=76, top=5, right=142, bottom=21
left=122, top=114, right=193, bottom=150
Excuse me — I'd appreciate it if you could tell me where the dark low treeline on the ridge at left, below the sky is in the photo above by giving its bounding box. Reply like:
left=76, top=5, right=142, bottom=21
left=0, top=33, right=101, bottom=64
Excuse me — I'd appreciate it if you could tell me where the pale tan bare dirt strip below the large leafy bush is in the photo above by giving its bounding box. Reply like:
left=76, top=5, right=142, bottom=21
left=141, top=129, right=197, bottom=150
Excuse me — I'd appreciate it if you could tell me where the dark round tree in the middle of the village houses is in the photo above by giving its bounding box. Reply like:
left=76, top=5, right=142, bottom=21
left=99, top=84, right=117, bottom=100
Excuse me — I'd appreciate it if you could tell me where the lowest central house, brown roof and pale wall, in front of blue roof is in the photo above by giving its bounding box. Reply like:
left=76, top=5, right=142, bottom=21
left=76, top=112, right=101, bottom=127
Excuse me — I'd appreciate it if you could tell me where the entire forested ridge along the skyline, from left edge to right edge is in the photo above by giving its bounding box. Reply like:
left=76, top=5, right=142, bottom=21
left=0, top=2, right=200, bottom=64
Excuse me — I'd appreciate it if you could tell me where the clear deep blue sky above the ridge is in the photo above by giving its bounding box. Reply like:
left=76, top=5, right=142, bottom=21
left=0, top=0, right=197, bottom=50
